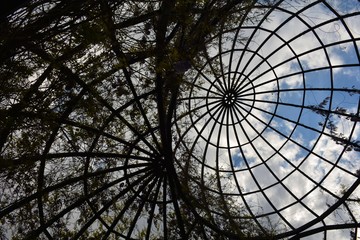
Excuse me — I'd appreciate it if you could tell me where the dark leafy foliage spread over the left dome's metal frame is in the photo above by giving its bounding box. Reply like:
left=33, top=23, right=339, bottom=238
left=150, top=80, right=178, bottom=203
left=0, top=0, right=290, bottom=239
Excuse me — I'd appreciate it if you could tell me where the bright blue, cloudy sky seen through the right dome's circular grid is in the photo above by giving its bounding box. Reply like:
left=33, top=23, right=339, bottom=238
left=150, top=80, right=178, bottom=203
left=177, top=0, right=360, bottom=239
